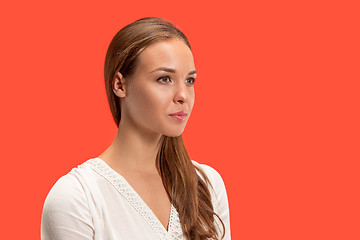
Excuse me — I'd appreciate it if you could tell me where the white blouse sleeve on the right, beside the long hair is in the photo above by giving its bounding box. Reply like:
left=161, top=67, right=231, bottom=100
left=195, top=164, right=231, bottom=240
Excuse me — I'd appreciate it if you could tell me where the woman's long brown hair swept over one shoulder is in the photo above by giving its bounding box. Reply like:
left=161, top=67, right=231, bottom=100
left=105, top=17, right=225, bottom=240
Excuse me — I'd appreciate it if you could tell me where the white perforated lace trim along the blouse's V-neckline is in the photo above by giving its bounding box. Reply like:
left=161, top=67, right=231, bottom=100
left=85, top=158, right=182, bottom=240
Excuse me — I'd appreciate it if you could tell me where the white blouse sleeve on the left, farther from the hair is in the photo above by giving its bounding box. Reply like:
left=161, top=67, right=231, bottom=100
left=41, top=172, right=94, bottom=240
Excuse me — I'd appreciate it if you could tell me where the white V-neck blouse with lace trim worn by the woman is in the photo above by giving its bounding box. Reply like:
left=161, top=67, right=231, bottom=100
left=41, top=158, right=230, bottom=240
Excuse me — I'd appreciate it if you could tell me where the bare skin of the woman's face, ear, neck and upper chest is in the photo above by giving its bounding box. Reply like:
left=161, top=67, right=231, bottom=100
left=99, top=38, right=196, bottom=229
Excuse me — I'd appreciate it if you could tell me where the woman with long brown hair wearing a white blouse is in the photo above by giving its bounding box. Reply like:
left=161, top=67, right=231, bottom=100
left=41, top=18, right=230, bottom=240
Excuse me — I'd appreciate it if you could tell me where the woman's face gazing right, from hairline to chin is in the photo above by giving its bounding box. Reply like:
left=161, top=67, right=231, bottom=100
left=120, top=38, right=196, bottom=137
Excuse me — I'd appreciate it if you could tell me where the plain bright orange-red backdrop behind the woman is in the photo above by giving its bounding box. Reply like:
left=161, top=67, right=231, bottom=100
left=0, top=0, right=360, bottom=240
